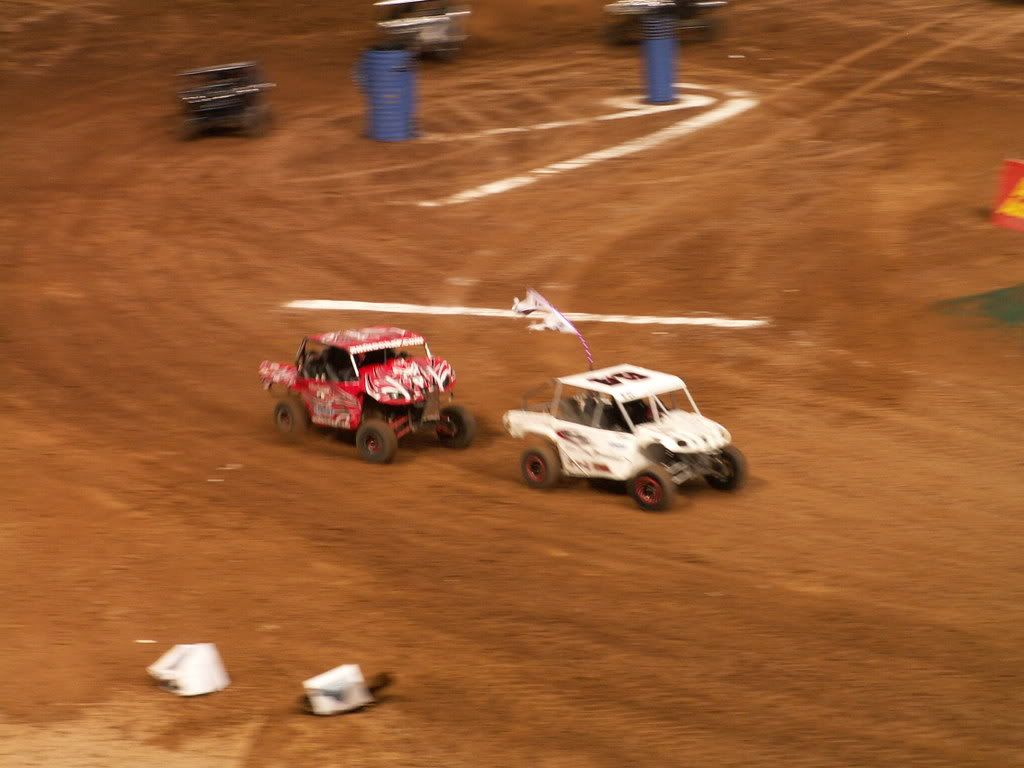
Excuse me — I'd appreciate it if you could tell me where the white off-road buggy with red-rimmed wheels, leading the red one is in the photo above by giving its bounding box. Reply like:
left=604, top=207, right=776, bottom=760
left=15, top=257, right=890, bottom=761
left=504, top=365, right=746, bottom=511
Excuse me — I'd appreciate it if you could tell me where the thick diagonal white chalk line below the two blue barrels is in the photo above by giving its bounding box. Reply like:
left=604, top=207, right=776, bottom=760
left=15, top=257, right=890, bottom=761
left=419, top=88, right=759, bottom=208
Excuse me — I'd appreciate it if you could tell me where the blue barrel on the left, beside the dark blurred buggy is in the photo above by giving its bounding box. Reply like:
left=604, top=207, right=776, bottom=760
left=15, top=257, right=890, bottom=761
left=358, top=46, right=416, bottom=141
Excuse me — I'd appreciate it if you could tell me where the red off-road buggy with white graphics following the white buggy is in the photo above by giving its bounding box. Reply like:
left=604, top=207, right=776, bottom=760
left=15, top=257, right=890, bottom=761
left=259, top=328, right=476, bottom=464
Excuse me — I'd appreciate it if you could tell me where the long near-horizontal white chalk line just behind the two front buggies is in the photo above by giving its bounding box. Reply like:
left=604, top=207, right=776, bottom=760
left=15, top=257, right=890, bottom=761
left=284, top=299, right=770, bottom=329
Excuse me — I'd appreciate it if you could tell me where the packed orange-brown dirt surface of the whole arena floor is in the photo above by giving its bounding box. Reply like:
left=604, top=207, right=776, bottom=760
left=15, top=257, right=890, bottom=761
left=0, top=0, right=1024, bottom=768
